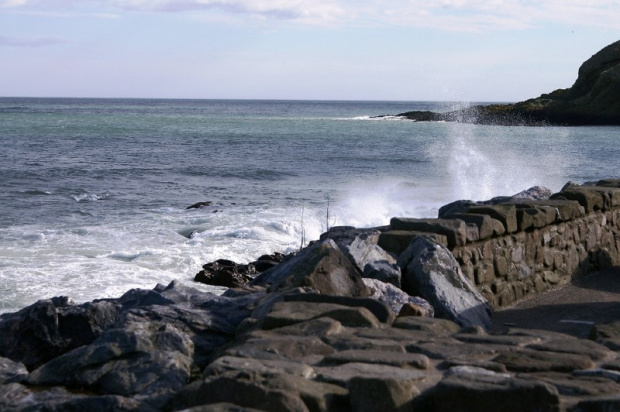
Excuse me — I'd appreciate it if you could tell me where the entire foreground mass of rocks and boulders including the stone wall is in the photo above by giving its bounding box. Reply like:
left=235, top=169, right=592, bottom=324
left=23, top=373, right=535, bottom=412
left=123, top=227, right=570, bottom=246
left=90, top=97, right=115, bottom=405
left=0, top=179, right=620, bottom=412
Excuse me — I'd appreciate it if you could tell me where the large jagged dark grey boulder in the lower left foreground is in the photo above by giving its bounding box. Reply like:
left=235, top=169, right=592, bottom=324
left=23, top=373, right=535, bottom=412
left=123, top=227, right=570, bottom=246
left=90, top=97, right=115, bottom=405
left=28, top=316, right=194, bottom=408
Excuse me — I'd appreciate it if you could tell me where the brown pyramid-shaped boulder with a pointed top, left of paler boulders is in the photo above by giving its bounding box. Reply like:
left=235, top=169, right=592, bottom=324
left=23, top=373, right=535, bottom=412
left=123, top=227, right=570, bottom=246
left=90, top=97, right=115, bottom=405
left=251, top=239, right=368, bottom=297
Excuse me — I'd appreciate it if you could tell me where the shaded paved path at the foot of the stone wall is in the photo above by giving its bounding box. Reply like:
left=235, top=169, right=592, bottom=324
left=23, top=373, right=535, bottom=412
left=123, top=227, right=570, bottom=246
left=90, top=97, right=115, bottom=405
left=491, top=267, right=620, bottom=338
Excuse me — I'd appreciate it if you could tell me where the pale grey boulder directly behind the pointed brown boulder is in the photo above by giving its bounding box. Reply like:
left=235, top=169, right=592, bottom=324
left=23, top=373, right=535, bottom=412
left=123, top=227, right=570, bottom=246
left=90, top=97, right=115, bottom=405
left=321, top=227, right=400, bottom=287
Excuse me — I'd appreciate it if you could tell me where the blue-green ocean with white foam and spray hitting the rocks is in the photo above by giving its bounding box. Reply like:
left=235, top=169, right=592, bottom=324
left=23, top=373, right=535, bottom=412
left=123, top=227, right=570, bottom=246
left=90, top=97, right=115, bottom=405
left=0, top=98, right=620, bottom=313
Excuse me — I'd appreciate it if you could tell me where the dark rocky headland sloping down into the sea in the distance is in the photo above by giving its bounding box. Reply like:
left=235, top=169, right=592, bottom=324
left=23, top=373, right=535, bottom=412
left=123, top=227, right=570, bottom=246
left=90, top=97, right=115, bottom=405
left=398, top=41, right=620, bottom=126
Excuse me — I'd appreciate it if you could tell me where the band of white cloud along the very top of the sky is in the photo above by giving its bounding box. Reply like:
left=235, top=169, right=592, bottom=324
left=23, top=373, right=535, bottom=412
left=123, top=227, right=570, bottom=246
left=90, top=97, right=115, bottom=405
left=0, top=0, right=620, bottom=32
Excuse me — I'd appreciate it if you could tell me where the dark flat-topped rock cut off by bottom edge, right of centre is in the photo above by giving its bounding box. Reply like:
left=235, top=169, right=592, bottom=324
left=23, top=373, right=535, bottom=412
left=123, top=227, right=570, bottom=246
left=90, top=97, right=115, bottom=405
left=413, top=375, right=562, bottom=412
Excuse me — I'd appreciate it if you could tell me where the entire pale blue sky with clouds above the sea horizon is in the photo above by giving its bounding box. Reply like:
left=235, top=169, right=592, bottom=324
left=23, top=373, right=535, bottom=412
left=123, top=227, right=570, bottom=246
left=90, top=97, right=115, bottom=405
left=0, top=0, right=620, bottom=102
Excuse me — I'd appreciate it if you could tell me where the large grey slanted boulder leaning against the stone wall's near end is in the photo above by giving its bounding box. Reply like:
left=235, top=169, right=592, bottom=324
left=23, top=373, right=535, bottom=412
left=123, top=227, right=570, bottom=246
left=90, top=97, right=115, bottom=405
left=398, top=238, right=491, bottom=328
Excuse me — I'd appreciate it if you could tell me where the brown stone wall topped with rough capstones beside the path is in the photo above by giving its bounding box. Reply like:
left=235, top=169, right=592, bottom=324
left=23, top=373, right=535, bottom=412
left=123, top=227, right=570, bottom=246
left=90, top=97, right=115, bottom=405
left=379, top=179, right=620, bottom=308
